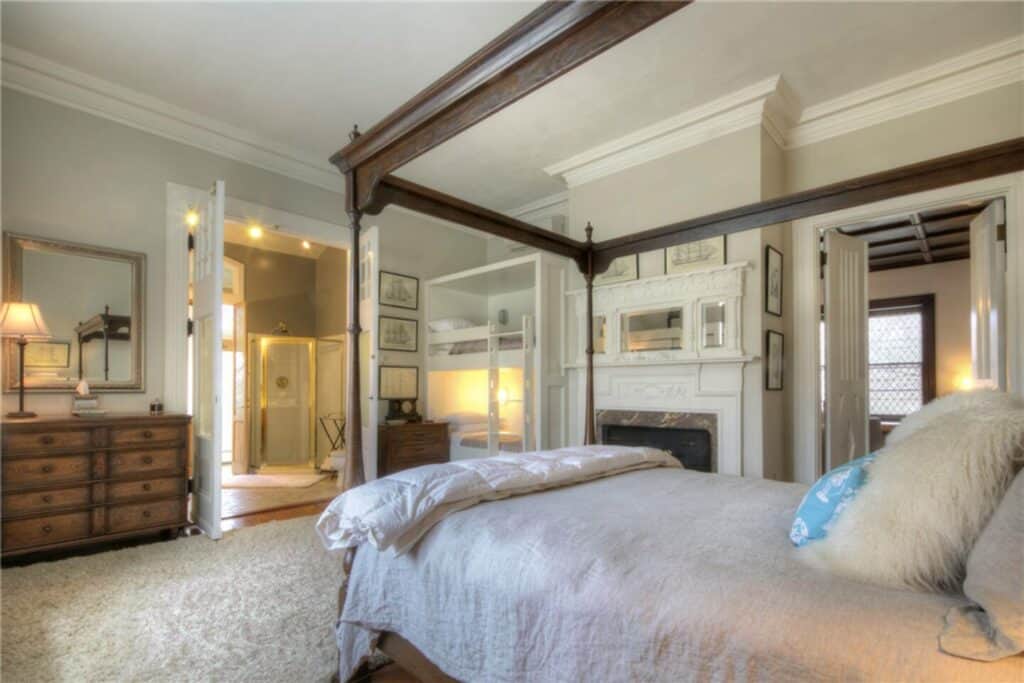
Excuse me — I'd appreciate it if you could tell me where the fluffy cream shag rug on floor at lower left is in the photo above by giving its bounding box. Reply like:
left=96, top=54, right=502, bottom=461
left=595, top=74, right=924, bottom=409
left=0, top=517, right=341, bottom=683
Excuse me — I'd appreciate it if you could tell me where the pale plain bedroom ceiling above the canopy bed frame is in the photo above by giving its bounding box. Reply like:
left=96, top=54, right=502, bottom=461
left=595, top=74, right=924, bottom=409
left=2, top=2, right=1024, bottom=210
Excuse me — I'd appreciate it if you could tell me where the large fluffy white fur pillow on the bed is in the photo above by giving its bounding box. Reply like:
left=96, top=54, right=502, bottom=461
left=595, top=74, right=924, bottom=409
left=799, top=392, right=1024, bottom=591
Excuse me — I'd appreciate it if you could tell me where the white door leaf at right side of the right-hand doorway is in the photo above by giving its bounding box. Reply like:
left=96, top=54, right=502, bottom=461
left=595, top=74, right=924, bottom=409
left=971, top=200, right=1007, bottom=389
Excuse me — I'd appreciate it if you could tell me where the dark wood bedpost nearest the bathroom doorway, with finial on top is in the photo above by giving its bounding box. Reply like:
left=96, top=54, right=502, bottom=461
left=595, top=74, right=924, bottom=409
left=345, top=126, right=367, bottom=488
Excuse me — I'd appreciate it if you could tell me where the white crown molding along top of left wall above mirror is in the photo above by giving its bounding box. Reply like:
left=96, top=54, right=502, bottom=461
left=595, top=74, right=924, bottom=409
left=0, top=45, right=342, bottom=194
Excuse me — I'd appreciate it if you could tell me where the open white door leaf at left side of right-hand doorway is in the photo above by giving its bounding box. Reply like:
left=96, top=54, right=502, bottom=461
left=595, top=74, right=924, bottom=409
left=824, top=230, right=868, bottom=470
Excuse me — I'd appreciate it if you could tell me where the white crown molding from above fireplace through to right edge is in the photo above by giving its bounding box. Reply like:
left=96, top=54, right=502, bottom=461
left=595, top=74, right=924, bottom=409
left=544, top=36, right=1024, bottom=187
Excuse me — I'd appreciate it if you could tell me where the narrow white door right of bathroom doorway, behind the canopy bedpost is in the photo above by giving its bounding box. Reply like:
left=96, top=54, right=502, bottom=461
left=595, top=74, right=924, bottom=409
left=349, top=225, right=380, bottom=481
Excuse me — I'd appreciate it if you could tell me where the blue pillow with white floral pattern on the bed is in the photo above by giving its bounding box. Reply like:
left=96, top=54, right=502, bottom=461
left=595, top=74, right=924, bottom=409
left=790, top=453, right=877, bottom=548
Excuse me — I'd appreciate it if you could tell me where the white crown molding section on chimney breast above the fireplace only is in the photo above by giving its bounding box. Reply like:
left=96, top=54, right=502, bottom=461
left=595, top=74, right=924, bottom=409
left=544, top=76, right=799, bottom=187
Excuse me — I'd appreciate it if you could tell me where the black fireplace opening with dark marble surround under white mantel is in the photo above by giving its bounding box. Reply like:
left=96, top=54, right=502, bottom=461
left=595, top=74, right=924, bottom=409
left=595, top=411, right=718, bottom=472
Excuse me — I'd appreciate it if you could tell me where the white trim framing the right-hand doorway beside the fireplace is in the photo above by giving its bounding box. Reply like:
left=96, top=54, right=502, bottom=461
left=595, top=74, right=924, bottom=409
left=788, top=172, right=1024, bottom=483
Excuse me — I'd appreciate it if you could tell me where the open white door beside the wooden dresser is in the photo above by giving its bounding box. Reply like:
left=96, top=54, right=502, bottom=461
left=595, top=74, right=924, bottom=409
left=193, top=180, right=224, bottom=539
